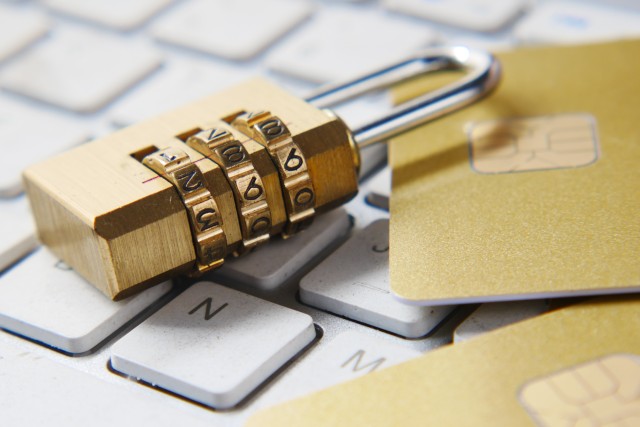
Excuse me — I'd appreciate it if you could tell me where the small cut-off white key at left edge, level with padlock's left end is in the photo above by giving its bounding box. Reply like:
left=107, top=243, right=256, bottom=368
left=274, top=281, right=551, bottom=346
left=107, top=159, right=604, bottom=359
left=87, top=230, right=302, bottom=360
left=0, top=197, right=38, bottom=271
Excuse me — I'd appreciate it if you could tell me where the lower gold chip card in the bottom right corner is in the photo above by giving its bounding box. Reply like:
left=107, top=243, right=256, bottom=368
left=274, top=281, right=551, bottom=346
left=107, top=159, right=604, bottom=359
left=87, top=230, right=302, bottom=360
left=249, top=297, right=640, bottom=427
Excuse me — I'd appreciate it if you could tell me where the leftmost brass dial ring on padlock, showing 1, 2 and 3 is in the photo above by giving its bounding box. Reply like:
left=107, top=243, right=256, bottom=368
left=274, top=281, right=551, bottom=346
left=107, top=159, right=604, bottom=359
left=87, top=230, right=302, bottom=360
left=142, top=148, right=227, bottom=272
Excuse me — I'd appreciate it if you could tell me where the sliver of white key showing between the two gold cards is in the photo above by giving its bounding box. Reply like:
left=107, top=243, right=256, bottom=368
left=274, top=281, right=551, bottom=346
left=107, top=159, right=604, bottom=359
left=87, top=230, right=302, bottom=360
left=453, top=300, right=549, bottom=342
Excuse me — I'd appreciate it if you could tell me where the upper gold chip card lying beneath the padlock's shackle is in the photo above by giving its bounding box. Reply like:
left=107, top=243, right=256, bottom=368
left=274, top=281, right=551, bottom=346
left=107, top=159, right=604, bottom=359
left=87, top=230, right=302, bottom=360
left=389, top=40, right=640, bottom=305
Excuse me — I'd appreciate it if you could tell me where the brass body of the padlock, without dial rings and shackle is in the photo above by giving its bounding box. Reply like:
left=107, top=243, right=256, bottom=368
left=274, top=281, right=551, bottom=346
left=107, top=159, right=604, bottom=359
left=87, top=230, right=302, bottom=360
left=24, top=79, right=357, bottom=299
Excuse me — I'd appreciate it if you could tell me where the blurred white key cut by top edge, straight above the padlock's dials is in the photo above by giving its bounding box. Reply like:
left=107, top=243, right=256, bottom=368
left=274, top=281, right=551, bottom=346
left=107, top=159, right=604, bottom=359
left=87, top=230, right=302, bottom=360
left=152, top=0, right=312, bottom=60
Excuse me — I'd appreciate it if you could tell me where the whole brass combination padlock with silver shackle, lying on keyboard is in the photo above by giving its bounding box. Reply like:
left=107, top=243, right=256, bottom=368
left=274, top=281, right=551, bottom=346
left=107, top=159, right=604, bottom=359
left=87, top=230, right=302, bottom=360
left=24, top=48, right=499, bottom=299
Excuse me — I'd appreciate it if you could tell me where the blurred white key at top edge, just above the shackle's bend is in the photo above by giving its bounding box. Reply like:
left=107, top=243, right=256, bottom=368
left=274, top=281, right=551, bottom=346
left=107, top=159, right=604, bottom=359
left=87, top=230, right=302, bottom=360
left=384, top=0, right=529, bottom=31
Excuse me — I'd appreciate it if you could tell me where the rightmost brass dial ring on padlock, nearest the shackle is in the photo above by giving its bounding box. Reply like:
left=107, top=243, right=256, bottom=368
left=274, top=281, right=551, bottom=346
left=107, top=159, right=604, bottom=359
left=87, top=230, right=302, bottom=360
left=232, top=111, right=315, bottom=237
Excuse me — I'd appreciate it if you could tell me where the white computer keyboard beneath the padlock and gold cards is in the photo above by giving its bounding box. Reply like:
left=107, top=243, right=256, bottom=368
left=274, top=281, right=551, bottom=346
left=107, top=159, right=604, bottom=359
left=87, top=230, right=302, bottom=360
left=0, top=0, right=640, bottom=426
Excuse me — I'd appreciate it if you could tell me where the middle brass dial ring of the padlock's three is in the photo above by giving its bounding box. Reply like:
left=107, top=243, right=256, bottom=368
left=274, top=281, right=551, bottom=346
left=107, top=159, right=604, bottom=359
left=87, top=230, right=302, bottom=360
left=187, top=123, right=272, bottom=249
